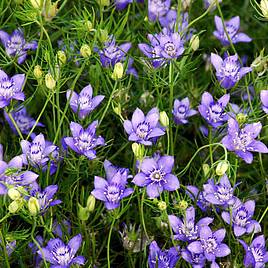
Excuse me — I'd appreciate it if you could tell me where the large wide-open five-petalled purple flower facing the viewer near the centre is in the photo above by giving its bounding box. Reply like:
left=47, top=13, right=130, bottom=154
left=132, top=155, right=180, bottom=198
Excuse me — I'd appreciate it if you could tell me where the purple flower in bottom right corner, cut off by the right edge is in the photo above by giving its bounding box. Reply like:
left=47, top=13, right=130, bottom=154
left=239, top=235, right=268, bottom=268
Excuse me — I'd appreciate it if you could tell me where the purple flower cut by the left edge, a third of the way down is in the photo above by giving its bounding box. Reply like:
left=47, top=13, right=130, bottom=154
left=0, top=70, right=25, bottom=108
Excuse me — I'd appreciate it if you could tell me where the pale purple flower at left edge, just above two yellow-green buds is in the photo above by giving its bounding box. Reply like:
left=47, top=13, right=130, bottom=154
left=0, top=156, right=38, bottom=195
